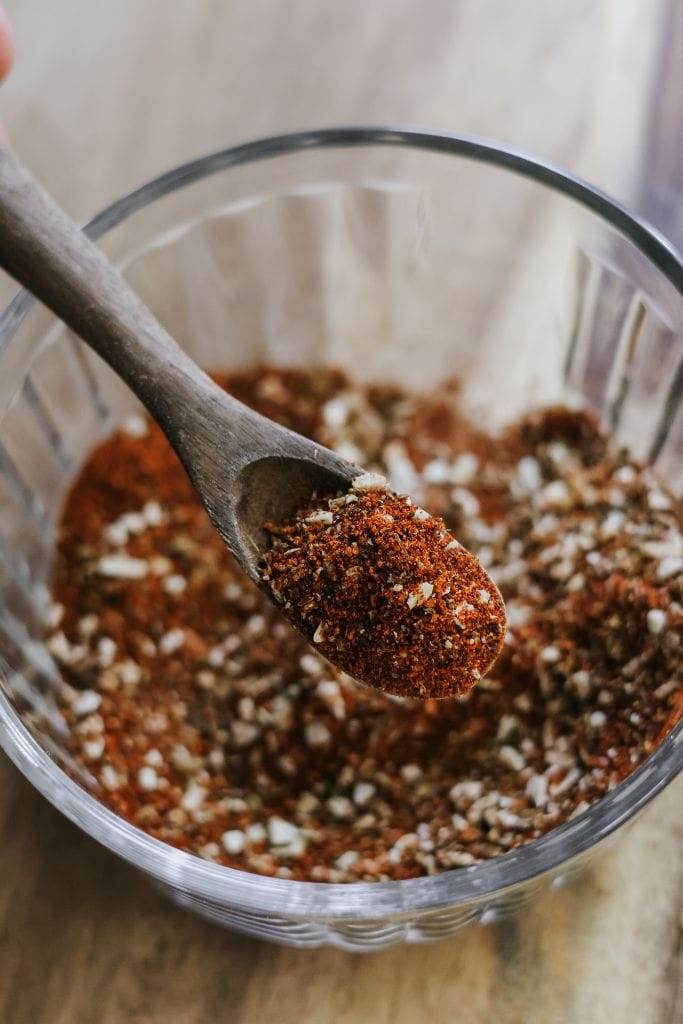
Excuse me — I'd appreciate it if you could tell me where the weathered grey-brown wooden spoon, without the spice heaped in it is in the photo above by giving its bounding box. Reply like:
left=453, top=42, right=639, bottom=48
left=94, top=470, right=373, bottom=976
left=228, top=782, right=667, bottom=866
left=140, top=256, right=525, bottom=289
left=0, top=147, right=360, bottom=582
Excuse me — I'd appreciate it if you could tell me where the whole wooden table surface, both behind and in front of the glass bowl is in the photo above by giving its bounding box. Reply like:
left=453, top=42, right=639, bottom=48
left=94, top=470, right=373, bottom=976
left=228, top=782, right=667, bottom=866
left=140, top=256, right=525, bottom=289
left=0, top=0, right=683, bottom=1024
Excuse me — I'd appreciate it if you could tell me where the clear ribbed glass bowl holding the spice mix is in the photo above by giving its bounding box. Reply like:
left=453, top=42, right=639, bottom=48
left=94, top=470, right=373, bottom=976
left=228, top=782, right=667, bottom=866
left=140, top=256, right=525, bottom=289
left=0, top=129, right=683, bottom=949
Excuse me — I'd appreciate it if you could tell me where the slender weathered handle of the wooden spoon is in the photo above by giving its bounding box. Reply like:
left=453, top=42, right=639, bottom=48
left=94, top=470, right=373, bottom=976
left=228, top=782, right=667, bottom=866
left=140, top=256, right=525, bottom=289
left=0, top=146, right=227, bottom=435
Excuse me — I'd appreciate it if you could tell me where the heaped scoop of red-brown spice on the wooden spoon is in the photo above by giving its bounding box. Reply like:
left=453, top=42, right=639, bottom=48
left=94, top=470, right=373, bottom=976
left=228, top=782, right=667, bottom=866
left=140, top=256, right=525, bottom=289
left=262, top=473, right=505, bottom=698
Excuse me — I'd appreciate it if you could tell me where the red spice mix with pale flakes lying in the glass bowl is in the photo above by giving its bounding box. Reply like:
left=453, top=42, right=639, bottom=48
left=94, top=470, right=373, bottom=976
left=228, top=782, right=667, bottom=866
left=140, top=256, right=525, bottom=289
left=48, top=367, right=683, bottom=882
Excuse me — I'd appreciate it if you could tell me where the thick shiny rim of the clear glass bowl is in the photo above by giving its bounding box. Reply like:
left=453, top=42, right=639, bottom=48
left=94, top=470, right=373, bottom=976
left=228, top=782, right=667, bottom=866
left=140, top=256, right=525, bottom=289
left=0, top=126, right=683, bottom=921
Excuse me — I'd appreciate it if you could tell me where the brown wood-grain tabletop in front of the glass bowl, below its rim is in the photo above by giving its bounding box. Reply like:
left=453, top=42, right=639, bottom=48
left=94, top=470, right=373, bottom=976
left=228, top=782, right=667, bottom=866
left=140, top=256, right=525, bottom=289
left=0, top=763, right=683, bottom=1024
